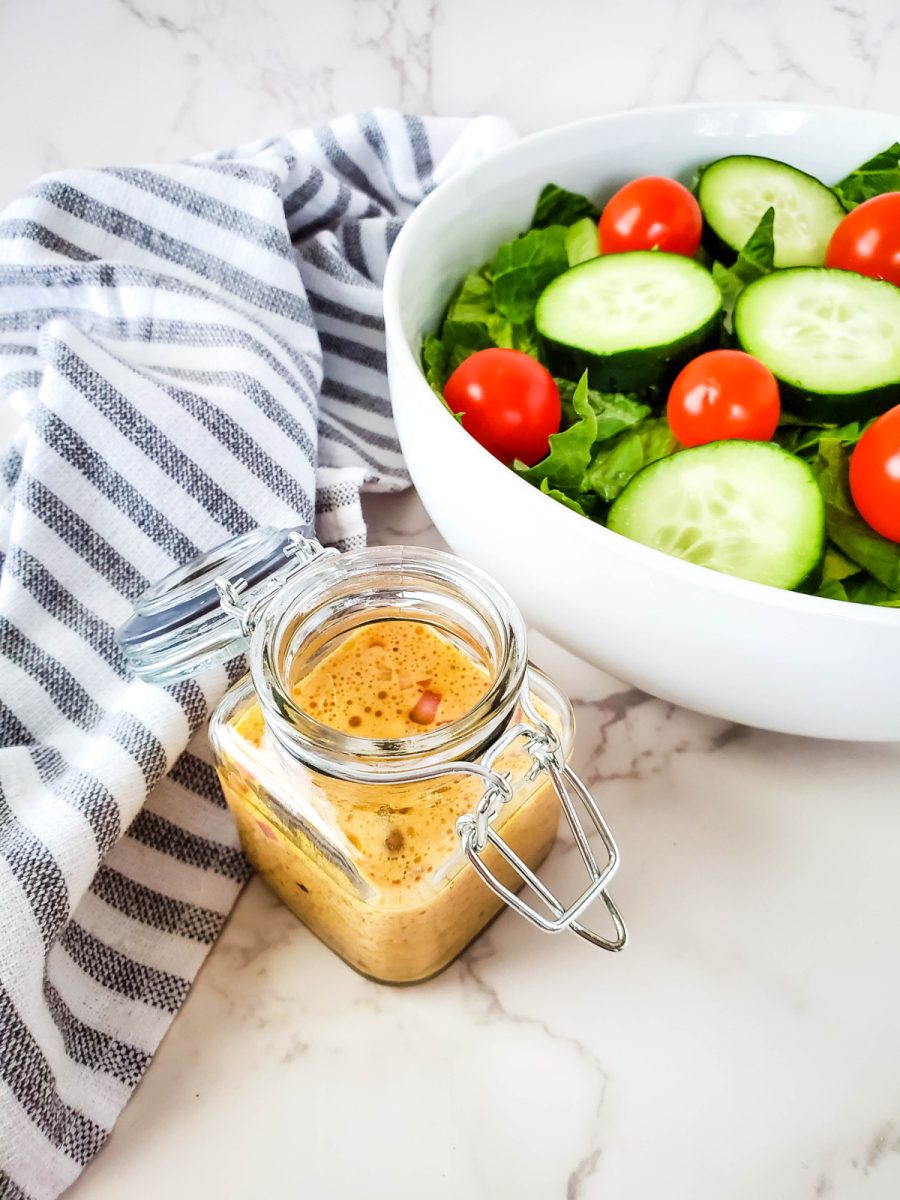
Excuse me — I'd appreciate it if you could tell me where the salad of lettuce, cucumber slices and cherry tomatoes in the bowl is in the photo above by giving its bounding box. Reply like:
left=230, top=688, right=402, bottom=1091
left=422, top=143, right=900, bottom=607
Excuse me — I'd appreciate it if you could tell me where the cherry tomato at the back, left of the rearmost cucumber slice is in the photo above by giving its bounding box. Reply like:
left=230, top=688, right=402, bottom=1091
left=600, top=175, right=703, bottom=258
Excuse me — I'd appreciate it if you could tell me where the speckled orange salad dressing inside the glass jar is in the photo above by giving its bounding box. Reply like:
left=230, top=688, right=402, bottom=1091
left=214, top=620, right=558, bottom=982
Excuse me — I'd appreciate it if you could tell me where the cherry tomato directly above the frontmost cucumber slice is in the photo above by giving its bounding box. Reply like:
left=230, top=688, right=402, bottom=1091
left=666, top=350, right=781, bottom=446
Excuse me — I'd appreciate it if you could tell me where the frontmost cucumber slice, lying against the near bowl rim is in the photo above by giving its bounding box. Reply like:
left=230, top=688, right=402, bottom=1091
left=608, top=442, right=824, bottom=588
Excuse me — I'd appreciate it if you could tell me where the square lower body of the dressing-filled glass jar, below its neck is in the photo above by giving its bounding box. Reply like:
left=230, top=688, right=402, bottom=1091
left=210, top=671, right=574, bottom=983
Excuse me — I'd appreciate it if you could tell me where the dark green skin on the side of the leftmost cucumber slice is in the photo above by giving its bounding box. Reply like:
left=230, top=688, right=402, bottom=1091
left=541, top=313, right=721, bottom=391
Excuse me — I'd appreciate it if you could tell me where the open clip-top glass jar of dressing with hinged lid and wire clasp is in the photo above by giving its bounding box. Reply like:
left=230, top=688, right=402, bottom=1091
left=119, top=529, right=626, bottom=983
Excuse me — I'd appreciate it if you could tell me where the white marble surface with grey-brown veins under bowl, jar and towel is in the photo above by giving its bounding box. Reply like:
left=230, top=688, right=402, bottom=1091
left=0, top=0, right=900, bottom=1200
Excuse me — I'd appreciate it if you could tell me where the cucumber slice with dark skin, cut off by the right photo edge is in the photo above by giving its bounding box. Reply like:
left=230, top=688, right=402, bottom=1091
left=734, top=266, right=900, bottom=422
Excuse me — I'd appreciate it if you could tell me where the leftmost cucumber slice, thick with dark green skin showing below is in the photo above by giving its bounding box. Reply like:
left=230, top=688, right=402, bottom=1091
left=534, top=251, right=722, bottom=391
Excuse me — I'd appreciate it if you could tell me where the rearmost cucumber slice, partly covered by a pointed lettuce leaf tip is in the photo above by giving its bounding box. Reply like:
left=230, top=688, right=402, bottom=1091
left=697, top=155, right=845, bottom=266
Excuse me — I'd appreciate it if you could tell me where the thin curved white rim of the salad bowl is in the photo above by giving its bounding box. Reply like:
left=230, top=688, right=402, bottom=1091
left=383, top=100, right=900, bottom=629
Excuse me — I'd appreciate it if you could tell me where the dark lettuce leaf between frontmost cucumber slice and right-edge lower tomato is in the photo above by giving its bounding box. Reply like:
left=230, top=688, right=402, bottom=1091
left=812, top=438, right=900, bottom=592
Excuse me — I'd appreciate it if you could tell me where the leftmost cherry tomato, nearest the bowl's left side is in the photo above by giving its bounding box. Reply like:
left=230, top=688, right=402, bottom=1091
left=444, top=349, right=560, bottom=467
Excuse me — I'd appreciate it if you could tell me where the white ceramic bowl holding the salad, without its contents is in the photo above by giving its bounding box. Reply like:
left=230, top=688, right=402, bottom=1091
left=384, top=103, right=900, bottom=740
